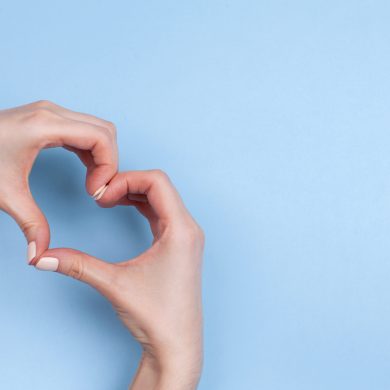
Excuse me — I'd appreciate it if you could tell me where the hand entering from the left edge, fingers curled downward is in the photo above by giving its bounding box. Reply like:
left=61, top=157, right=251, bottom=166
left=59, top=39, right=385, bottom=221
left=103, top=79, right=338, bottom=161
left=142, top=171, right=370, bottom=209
left=0, top=101, right=118, bottom=262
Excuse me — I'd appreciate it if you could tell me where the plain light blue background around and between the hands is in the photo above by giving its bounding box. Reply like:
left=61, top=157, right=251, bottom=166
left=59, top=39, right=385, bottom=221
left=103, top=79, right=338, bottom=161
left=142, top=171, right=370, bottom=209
left=0, top=0, right=390, bottom=390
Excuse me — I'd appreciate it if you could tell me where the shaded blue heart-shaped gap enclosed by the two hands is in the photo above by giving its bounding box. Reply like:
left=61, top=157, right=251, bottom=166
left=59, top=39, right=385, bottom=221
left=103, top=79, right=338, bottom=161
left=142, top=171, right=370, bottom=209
left=30, top=150, right=151, bottom=261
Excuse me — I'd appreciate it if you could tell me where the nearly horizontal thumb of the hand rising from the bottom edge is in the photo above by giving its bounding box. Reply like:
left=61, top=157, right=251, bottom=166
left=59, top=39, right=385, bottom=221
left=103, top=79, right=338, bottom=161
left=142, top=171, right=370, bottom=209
left=32, top=248, right=116, bottom=296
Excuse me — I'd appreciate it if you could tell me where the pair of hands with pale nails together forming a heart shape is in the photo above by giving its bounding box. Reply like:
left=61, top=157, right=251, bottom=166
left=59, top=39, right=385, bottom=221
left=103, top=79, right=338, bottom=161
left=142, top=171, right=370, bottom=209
left=0, top=101, right=204, bottom=390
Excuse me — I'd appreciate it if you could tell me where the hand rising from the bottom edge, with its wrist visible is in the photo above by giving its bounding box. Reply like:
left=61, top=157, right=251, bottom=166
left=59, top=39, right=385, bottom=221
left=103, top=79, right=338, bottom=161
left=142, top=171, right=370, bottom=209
left=34, top=170, right=204, bottom=390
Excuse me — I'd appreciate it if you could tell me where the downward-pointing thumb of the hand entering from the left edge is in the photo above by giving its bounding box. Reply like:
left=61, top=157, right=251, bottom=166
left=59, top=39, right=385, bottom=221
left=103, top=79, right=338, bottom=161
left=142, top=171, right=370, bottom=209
left=4, top=188, right=50, bottom=263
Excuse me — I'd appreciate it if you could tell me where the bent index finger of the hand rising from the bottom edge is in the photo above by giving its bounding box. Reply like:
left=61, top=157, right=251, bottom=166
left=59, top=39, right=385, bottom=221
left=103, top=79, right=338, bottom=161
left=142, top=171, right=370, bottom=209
left=99, top=170, right=187, bottom=221
